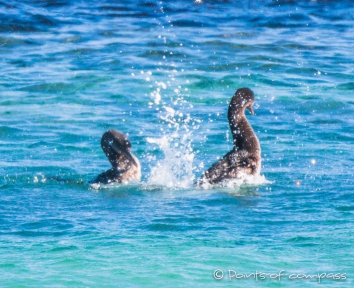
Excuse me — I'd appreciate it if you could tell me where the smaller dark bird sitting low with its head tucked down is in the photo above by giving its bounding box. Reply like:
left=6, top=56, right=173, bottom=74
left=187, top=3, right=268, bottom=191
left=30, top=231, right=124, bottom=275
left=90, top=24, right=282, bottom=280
left=91, top=130, right=141, bottom=184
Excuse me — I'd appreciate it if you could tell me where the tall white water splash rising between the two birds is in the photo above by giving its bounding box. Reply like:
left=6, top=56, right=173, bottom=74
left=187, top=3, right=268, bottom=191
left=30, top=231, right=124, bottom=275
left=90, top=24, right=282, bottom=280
left=146, top=75, right=201, bottom=188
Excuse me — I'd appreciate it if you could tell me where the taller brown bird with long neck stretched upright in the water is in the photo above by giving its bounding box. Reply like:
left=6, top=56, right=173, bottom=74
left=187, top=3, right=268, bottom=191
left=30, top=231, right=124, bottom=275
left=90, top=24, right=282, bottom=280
left=197, top=88, right=261, bottom=185
